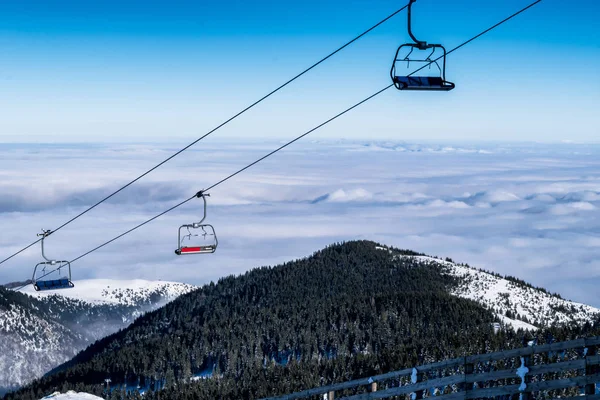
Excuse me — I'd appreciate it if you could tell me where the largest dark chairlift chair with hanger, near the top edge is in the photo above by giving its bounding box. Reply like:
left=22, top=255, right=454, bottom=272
left=390, top=0, right=455, bottom=92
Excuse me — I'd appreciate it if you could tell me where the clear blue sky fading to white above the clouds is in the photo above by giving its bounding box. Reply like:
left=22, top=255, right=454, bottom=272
left=0, top=0, right=600, bottom=142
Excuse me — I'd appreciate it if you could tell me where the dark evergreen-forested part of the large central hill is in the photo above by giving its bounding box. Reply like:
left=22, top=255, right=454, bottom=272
left=8, top=241, right=595, bottom=399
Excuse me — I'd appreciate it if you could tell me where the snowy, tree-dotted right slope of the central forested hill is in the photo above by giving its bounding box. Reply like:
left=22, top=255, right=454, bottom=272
left=378, top=247, right=600, bottom=330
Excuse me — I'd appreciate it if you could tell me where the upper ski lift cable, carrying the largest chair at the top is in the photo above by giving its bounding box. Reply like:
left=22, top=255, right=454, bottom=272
left=0, top=4, right=408, bottom=264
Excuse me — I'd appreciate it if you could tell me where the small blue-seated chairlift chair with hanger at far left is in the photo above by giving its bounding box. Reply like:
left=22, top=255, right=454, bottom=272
left=31, top=230, right=75, bottom=291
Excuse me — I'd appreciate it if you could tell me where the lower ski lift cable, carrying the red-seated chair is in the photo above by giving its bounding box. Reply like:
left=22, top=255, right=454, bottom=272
left=16, top=0, right=542, bottom=290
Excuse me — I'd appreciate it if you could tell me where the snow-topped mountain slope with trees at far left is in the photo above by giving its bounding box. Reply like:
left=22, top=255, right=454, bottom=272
left=0, top=279, right=195, bottom=395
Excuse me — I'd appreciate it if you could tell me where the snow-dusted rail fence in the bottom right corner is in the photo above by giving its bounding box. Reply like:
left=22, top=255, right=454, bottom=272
left=262, top=336, right=600, bottom=400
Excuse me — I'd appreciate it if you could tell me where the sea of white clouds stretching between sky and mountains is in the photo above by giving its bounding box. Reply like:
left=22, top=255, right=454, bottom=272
left=0, top=141, right=600, bottom=306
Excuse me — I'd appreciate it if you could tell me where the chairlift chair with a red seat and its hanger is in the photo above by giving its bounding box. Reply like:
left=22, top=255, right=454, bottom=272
left=175, top=192, right=219, bottom=256
